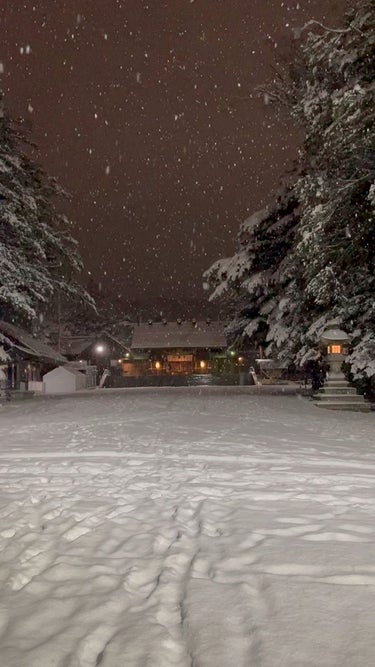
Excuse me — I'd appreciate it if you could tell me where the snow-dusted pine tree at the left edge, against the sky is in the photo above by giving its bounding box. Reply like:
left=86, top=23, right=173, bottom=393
left=0, top=102, right=90, bottom=323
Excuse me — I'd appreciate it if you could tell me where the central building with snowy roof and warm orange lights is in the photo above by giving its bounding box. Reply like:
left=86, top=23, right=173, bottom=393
left=129, top=319, right=227, bottom=376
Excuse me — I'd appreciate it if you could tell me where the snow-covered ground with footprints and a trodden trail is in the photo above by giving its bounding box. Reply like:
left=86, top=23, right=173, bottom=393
left=0, top=387, right=375, bottom=667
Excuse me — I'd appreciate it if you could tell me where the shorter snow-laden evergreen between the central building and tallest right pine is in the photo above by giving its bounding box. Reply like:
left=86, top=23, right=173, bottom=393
left=204, top=180, right=300, bottom=354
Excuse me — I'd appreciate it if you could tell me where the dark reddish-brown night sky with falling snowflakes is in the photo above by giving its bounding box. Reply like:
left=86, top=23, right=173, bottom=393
left=0, top=0, right=345, bottom=314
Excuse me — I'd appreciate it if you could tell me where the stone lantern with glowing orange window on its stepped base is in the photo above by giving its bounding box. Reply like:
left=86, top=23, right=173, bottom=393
left=315, top=320, right=370, bottom=412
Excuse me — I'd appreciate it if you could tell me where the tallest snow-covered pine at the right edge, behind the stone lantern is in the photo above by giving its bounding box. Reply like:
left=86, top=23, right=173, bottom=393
left=289, top=0, right=375, bottom=377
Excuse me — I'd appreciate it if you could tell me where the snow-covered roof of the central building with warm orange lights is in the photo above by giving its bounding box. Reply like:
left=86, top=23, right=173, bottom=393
left=131, top=321, right=227, bottom=350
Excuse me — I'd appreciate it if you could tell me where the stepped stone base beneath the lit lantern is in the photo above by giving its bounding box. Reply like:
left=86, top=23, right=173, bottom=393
left=314, top=377, right=371, bottom=412
